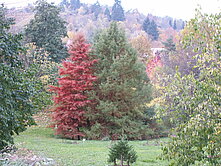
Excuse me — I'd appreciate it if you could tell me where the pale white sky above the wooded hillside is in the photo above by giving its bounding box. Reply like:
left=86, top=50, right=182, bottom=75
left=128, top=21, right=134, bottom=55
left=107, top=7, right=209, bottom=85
left=0, top=0, right=221, bottom=20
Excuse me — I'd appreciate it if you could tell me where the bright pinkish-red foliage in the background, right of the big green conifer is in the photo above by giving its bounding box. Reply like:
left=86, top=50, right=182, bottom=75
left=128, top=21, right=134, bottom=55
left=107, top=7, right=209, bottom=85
left=146, top=55, right=163, bottom=79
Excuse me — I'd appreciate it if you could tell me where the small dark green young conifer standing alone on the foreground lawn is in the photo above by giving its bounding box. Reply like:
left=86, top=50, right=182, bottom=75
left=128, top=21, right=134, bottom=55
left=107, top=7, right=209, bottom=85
left=108, top=140, right=137, bottom=166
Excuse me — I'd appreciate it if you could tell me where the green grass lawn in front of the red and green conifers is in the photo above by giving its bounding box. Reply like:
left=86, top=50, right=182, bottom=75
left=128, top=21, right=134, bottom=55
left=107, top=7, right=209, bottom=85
left=15, top=126, right=167, bottom=166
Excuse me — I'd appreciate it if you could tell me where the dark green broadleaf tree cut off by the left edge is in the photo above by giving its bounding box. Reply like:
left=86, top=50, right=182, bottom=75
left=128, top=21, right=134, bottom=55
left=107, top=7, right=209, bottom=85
left=0, top=6, right=34, bottom=149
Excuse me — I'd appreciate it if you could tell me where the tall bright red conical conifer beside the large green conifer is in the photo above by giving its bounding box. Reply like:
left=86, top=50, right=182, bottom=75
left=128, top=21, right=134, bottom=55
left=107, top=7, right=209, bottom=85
left=51, top=35, right=96, bottom=139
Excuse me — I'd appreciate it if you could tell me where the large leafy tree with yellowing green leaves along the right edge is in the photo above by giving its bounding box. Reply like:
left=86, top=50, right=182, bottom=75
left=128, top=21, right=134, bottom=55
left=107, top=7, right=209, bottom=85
left=159, top=12, right=221, bottom=166
